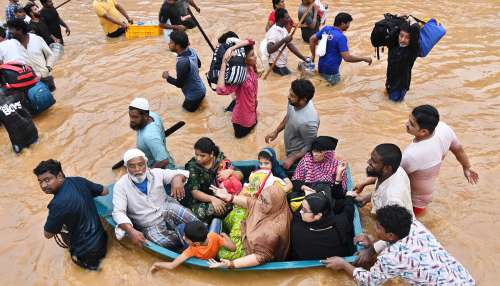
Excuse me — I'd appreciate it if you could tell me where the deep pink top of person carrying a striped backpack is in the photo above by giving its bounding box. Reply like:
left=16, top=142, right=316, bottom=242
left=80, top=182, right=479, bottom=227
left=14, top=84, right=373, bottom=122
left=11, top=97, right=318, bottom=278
left=216, top=67, right=258, bottom=127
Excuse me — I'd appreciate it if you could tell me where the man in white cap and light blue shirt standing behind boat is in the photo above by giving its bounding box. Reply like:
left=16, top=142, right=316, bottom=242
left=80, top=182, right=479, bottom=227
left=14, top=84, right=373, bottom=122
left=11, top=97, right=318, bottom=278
left=128, top=98, right=175, bottom=169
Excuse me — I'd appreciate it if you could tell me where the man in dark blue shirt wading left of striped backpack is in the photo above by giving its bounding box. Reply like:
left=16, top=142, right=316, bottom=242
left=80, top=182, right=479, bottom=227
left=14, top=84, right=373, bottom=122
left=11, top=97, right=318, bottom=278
left=162, top=31, right=206, bottom=112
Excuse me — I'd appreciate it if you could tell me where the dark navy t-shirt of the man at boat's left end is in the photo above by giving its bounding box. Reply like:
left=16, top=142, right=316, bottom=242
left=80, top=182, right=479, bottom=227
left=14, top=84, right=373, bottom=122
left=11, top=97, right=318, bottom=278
left=44, top=177, right=106, bottom=257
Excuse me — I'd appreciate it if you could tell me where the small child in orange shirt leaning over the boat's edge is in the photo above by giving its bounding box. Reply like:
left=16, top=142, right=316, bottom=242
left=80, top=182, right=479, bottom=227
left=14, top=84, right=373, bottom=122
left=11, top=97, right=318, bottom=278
left=151, top=221, right=236, bottom=273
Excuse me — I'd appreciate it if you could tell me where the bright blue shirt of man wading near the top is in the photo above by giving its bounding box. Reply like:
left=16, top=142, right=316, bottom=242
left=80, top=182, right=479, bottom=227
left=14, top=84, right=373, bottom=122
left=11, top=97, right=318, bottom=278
left=316, top=26, right=349, bottom=74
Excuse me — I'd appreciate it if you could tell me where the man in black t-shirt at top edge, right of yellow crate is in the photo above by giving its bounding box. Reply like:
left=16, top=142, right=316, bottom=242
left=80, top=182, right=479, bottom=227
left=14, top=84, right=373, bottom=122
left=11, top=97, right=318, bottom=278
left=159, top=0, right=201, bottom=31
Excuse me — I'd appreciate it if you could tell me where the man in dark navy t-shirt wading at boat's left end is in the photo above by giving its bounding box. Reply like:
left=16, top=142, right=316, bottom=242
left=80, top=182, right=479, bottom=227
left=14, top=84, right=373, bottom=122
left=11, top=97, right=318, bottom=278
left=33, top=159, right=108, bottom=270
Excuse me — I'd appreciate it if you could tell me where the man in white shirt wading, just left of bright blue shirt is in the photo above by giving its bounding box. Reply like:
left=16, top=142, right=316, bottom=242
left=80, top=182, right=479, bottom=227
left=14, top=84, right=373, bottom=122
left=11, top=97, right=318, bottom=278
left=266, top=8, right=307, bottom=76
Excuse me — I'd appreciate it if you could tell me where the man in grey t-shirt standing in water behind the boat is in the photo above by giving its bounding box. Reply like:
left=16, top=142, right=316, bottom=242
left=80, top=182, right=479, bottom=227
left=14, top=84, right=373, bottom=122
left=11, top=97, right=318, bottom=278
left=265, top=79, right=319, bottom=169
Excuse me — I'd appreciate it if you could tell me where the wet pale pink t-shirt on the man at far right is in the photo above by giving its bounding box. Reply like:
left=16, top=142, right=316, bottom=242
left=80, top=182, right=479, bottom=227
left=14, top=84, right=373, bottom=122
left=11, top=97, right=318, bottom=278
left=401, top=121, right=460, bottom=208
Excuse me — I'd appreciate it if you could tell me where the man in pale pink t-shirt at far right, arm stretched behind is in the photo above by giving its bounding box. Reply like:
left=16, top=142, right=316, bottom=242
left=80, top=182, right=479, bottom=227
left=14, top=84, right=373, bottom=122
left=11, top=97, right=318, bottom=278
left=401, top=105, right=479, bottom=215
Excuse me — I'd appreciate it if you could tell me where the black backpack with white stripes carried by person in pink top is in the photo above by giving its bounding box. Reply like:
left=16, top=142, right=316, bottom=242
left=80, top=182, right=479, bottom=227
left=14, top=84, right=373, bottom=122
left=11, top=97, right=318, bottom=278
left=207, top=43, right=247, bottom=90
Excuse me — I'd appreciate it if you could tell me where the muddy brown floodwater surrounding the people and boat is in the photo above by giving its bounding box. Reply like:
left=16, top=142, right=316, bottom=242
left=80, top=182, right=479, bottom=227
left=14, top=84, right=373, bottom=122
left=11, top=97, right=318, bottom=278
left=0, top=0, right=500, bottom=285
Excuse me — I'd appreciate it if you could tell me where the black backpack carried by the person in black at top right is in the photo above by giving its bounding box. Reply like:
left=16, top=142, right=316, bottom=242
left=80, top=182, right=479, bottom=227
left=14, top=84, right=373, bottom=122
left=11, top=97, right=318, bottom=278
left=370, top=13, right=405, bottom=59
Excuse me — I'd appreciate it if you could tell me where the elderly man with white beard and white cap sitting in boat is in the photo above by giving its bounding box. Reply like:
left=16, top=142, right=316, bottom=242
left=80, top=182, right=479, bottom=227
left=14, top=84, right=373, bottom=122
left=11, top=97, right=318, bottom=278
left=113, top=149, right=199, bottom=251
